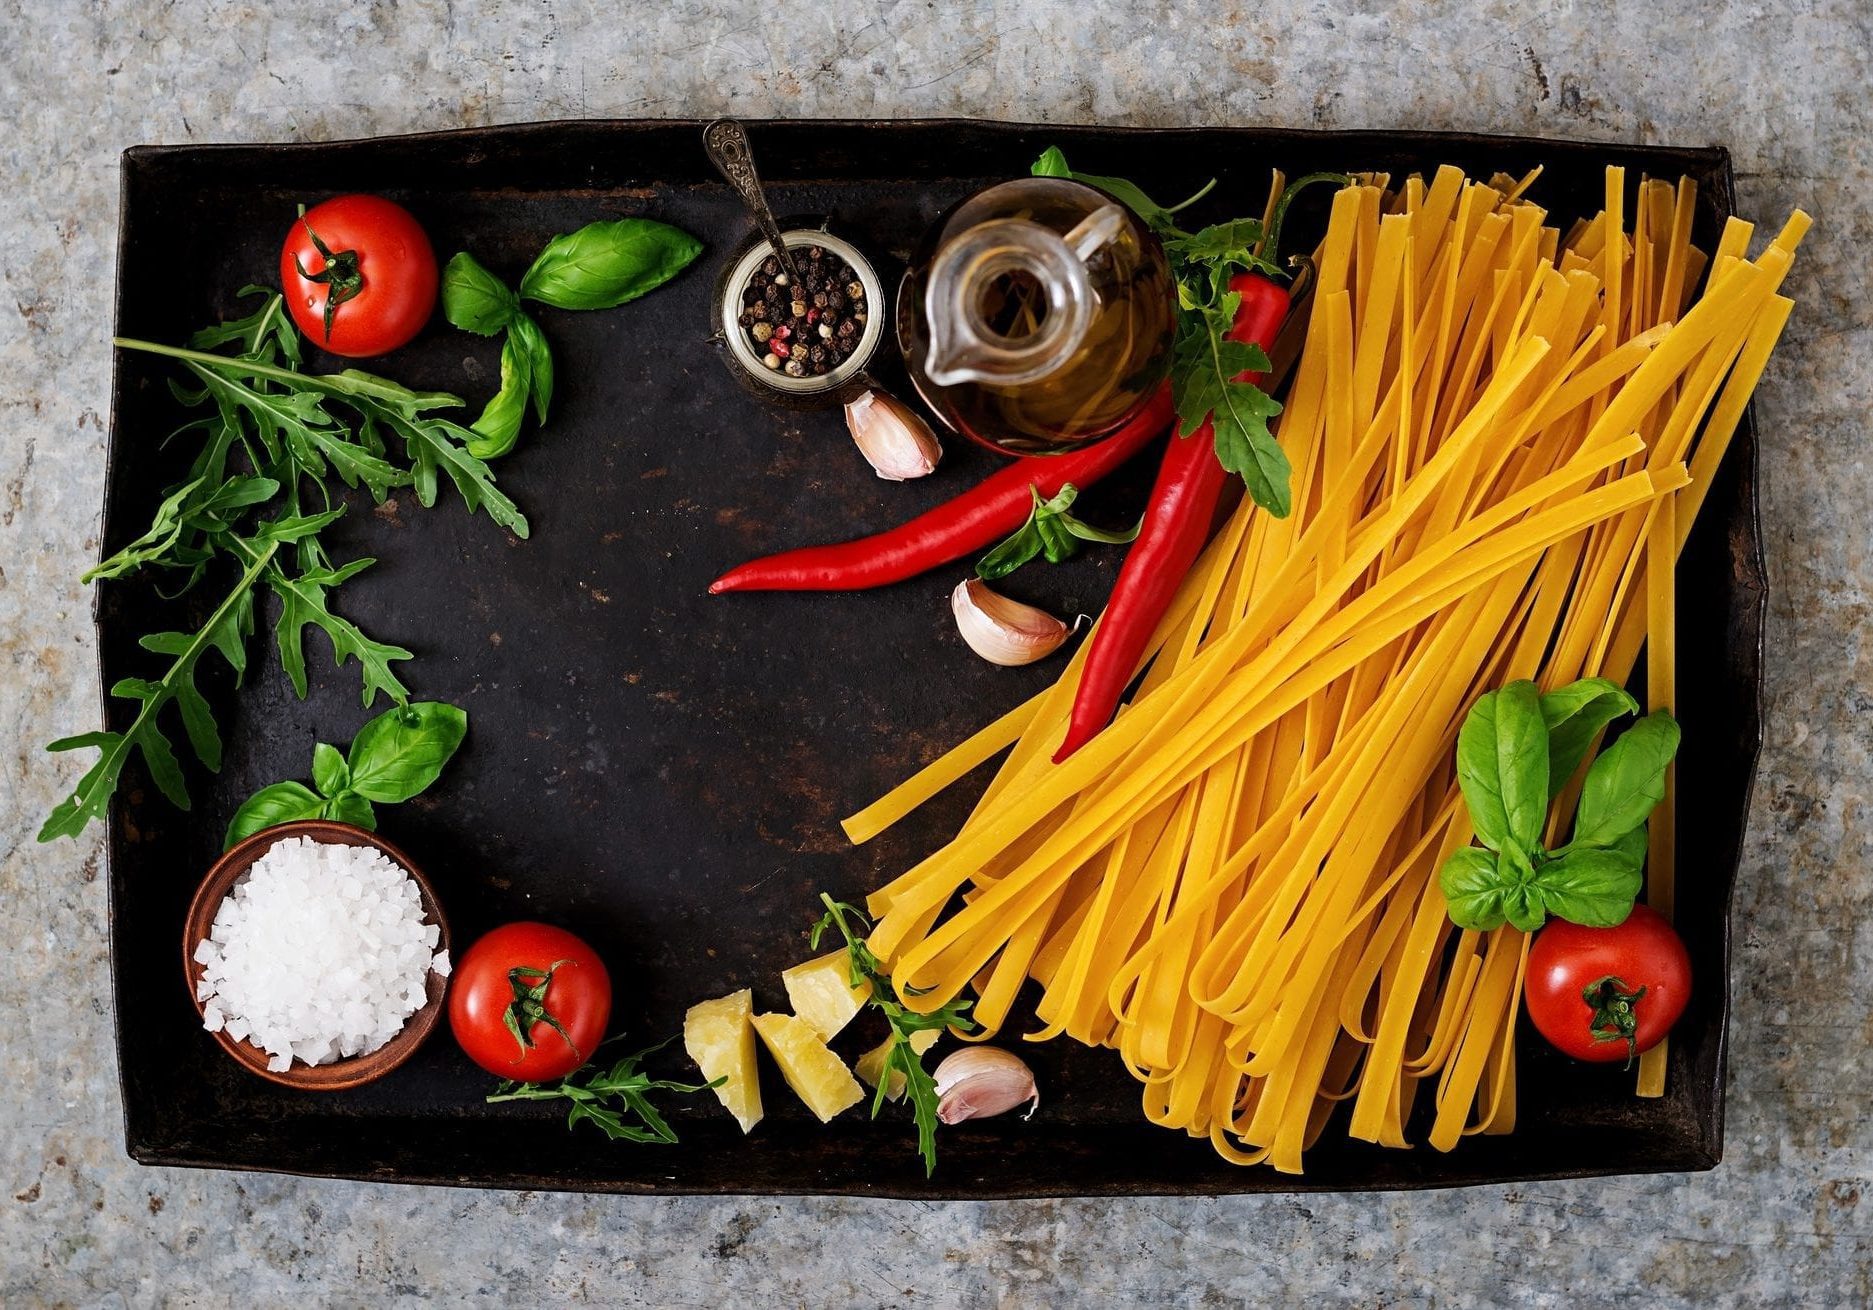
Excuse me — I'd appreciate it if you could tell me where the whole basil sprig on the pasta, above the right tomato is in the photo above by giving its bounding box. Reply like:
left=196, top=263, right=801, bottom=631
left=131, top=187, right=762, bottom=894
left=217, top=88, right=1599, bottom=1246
left=1438, top=678, right=1678, bottom=931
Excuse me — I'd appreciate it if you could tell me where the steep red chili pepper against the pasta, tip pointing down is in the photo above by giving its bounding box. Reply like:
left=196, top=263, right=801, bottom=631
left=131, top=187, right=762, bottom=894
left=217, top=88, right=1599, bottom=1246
left=1054, top=274, right=1289, bottom=765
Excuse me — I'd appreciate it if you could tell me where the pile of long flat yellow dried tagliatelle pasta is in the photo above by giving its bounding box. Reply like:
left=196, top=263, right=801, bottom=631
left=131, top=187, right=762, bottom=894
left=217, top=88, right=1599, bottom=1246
left=847, top=169, right=1807, bottom=1171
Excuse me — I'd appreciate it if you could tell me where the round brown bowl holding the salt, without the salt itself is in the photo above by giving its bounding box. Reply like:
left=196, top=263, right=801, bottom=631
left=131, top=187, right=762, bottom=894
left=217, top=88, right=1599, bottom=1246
left=182, top=819, right=450, bottom=1091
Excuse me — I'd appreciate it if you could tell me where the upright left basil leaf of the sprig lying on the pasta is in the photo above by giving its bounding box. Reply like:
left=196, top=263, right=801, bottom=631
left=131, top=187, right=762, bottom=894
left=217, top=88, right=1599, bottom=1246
left=1457, top=680, right=1547, bottom=853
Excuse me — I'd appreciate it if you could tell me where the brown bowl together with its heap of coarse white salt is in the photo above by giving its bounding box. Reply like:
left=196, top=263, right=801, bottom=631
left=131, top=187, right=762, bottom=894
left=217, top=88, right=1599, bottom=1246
left=182, top=819, right=450, bottom=1091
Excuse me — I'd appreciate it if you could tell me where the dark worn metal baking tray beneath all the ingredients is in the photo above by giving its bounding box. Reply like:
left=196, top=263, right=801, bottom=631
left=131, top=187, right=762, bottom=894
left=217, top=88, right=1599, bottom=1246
left=102, top=122, right=1764, bottom=1198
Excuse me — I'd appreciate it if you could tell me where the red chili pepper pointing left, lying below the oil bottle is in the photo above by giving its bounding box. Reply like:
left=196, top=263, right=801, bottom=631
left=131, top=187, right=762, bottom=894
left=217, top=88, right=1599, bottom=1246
left=708, top=386, right=1168, bottom=592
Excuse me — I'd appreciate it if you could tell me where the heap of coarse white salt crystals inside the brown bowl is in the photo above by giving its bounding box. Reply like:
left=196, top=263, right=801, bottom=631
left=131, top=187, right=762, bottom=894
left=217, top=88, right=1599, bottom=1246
left=195, top=838, right=450, bottom=1074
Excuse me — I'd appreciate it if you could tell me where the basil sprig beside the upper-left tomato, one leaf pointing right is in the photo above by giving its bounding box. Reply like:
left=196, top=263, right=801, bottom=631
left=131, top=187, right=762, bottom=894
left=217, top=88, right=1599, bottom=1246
left=442, top=217, right=702, bottom=459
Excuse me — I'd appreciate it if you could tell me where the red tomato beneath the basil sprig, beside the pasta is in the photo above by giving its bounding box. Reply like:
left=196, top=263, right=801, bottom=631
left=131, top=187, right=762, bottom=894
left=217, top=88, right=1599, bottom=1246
left=1526, top=905, right=1691, bottom=1063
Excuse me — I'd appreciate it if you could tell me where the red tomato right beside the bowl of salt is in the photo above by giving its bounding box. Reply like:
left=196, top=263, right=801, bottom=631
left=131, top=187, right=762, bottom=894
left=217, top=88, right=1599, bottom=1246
left=450, top=924, right=611, bottom=1083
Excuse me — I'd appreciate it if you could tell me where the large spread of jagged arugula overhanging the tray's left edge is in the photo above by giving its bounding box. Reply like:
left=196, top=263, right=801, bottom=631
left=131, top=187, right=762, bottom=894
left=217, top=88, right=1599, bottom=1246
left=39, top=287, right=526, bottom=841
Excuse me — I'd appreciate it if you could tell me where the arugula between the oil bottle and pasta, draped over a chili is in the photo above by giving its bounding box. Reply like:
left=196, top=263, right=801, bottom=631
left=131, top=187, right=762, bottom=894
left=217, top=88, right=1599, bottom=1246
left=1032, top=146, right=1350, bottom=519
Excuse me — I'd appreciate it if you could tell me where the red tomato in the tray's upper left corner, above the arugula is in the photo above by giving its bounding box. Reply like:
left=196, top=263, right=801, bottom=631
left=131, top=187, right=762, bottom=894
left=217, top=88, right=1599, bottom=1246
left=279, top=195, right=436, bottom=358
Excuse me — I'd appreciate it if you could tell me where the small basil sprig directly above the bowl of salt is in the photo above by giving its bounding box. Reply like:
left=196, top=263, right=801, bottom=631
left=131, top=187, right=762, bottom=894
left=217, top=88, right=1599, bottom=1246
left=227, top=701, right=468, bottom=847
